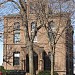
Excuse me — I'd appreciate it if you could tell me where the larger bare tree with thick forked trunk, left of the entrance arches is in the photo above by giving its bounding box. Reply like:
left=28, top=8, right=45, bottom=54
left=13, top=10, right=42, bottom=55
left=0, top=0, right=40, bottom=75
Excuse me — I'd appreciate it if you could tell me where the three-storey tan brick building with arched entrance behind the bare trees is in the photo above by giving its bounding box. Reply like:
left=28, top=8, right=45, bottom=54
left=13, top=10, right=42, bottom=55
left=3, top=0, right=73, bottom=75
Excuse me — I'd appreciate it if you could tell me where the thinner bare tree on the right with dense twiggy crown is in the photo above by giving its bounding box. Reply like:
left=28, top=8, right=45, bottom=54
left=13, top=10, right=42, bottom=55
left=35, top=0, right=74, bottom=75
